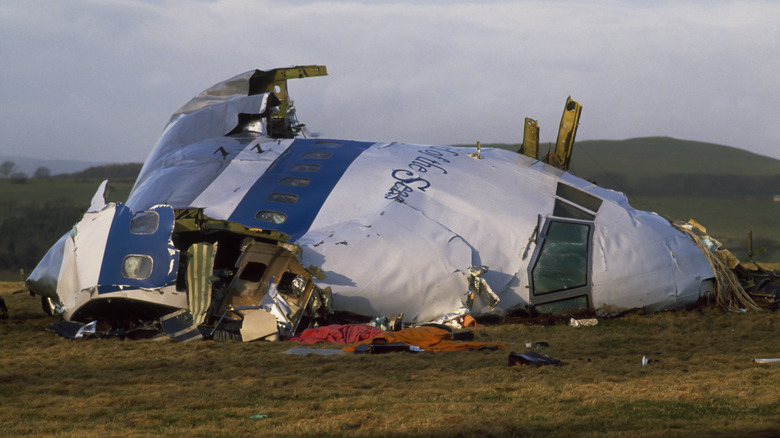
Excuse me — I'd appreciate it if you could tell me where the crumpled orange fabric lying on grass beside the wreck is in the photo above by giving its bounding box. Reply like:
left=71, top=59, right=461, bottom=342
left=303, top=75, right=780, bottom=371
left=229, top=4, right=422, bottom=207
left=344, top=327, right=504, bottom=353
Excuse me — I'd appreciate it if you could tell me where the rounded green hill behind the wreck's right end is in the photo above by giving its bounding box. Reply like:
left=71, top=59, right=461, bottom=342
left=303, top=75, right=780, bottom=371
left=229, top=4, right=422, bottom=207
left=470, top=137, right=780, bottom=200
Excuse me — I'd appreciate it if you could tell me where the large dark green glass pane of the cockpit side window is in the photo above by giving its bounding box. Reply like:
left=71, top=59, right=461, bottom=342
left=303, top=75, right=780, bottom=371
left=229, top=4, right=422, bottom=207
left=532, top=221, right=590, bottom=295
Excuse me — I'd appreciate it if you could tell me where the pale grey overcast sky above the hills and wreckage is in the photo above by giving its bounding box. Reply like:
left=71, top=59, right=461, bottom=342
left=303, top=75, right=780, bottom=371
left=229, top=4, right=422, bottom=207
left=0, top=0, right=780, bottom=162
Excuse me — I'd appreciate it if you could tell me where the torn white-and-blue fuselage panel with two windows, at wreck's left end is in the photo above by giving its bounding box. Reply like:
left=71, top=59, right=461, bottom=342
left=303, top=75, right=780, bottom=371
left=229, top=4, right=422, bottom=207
left=26, top=200, right=186, bottom=321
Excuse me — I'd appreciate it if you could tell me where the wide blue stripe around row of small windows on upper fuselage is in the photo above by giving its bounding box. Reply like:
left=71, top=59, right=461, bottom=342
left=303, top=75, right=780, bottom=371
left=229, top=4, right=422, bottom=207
left=228, top=139, right=374, bottom=241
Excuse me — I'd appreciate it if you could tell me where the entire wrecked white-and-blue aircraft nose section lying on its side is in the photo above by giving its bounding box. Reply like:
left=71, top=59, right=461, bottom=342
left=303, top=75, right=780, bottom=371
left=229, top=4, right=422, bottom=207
left=27, top=66, right=736, bottom=340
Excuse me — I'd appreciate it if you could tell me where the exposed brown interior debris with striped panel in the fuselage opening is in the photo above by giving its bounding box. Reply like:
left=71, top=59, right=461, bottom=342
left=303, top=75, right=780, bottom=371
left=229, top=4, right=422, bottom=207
left=161, top=235, right=331, bottom=342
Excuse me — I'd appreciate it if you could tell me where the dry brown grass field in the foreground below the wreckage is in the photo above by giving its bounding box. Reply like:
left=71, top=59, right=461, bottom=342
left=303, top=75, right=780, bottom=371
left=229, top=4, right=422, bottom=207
left=0, top=283, right=780, bottom=437
